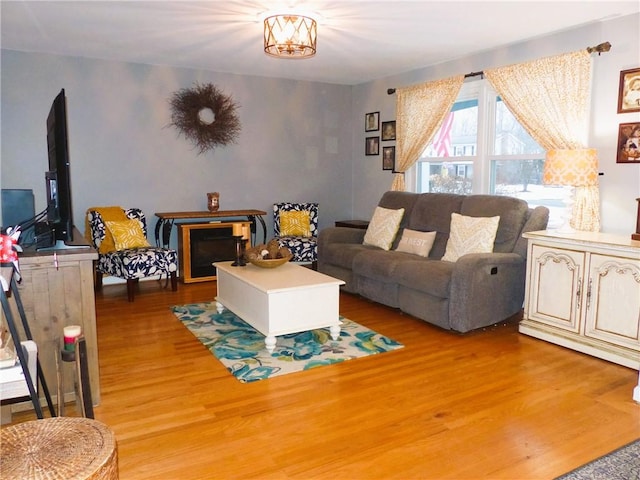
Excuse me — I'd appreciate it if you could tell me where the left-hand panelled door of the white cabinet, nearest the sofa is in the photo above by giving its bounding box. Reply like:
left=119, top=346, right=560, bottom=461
left=528, top=244, right=585, bottom=333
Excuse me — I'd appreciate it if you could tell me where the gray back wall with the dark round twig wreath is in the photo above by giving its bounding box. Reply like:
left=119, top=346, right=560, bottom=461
left=1, top=50, right=352, bottom=245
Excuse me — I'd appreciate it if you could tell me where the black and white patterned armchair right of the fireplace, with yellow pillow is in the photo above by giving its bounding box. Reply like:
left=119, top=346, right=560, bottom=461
left=273, top=202, right=318, bottom=270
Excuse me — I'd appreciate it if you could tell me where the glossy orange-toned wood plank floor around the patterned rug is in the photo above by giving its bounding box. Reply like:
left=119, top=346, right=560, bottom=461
left=8, top=282, right=640, bottom=480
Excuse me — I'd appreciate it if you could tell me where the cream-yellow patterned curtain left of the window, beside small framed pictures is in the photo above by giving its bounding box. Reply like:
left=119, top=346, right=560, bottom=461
left=391, top=75, right=464, bottom=191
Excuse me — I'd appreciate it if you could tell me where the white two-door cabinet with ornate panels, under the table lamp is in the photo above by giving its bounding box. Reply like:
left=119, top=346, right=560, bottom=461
left=519, top=231, right=640, bottom=369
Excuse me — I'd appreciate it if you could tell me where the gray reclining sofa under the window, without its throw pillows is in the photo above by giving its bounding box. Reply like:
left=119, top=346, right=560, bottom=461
left=318, top=191, right=549, bottom=332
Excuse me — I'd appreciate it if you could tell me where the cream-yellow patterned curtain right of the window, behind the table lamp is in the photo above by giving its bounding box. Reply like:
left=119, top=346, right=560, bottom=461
left=484, top=50, right=600, bottom=232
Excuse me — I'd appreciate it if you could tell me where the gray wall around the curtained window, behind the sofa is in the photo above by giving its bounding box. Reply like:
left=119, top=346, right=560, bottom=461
left=351, top=15, right=640, bottom=235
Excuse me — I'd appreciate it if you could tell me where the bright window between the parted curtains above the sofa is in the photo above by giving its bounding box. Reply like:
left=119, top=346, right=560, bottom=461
left=416, top=80, right=566, bottom=228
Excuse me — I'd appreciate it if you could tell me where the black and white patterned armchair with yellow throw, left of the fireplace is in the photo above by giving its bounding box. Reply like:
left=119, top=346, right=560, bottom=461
left=86, top=207, right=178, bottom=302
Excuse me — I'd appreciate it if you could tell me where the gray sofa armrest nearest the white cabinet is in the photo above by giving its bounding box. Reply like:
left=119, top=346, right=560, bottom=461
left=449, top=253, right=526, bottom=332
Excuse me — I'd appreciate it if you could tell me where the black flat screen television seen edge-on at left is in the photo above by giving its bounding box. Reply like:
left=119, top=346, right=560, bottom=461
left=38, top=88, right=86, bottom=250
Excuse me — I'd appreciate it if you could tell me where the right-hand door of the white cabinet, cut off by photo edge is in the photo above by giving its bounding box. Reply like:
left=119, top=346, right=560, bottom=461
left=585, top=254, right=640, bottom=351
